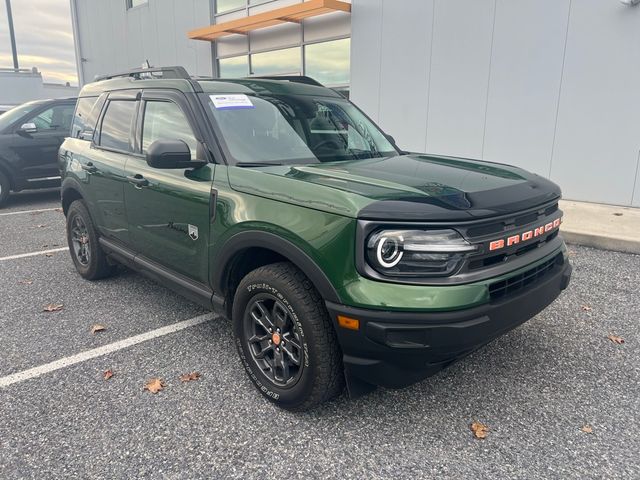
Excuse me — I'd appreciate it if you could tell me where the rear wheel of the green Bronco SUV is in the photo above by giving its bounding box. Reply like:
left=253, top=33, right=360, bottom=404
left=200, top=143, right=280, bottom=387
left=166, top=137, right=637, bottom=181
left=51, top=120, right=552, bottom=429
left=67, top=200, right=114, bottom=280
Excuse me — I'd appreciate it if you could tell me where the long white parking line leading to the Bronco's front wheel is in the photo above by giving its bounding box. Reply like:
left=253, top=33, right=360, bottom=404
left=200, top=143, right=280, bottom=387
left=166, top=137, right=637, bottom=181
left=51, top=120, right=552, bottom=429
left=0, top=313, right=214, bottom=388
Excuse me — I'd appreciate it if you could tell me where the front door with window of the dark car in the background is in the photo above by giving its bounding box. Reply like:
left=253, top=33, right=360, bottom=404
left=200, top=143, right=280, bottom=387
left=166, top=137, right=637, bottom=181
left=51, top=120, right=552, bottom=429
left=9, top=103, right=74, bottom=180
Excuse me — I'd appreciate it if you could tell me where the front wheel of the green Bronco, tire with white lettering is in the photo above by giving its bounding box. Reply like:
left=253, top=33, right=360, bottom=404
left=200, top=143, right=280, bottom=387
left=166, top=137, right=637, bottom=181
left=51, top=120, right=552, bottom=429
left=232, top=262, right=344, bottom=411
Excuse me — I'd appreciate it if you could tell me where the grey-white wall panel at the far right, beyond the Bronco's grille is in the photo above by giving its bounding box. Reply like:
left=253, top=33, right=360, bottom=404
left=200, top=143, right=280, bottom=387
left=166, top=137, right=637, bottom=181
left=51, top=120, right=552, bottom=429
left=551, top=0, right=640, bottom=205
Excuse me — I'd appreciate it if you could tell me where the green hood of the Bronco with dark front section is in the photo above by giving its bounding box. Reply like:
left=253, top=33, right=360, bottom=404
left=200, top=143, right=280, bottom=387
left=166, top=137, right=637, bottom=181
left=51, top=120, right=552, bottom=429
left=230, top=154, right=560, bottom=221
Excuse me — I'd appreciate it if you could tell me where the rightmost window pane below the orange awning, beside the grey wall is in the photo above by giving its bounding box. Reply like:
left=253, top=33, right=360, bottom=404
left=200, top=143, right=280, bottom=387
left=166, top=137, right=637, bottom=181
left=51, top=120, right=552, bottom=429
left=304, top=38, right=351, bottom=85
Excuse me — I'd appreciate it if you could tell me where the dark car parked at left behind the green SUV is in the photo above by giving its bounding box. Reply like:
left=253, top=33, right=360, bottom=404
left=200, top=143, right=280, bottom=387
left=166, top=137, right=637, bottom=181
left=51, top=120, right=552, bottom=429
left=0, top=98, right=76, bottom=207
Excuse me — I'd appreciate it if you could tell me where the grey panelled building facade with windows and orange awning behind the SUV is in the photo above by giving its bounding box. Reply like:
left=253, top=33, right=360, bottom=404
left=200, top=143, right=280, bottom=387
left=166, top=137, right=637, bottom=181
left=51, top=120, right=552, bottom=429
left=71, top=0, right=640, bottom=206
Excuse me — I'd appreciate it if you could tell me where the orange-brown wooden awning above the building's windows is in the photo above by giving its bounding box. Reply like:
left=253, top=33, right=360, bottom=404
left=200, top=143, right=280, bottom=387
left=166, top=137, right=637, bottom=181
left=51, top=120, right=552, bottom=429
left=188, top=0, right=351, bottom=42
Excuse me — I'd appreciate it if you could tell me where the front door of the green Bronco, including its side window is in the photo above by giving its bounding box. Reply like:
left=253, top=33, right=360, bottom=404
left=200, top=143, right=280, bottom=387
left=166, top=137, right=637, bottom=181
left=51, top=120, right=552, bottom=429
left=125, top=91, right=214, bottom=283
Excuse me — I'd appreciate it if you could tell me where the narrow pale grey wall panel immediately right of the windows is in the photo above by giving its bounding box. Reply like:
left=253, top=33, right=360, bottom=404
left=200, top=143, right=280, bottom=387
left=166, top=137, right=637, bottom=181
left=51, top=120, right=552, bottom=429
left=351, top=0, right=383, bottom=121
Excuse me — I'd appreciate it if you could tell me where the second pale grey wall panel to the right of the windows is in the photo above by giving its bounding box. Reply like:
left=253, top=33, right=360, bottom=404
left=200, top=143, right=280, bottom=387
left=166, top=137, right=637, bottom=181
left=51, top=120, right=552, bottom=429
left=378, top=0, right=434, bottom=152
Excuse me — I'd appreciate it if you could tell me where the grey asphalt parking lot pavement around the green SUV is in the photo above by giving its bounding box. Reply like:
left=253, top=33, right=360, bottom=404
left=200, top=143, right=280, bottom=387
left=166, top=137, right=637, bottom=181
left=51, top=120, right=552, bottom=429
left=0, top=191, right=640, bottom=479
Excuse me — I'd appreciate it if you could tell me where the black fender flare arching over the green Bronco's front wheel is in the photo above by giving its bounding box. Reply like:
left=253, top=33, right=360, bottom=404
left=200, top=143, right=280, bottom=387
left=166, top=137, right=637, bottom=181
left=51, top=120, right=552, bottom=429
left=212, top=230, right=342, bottom=303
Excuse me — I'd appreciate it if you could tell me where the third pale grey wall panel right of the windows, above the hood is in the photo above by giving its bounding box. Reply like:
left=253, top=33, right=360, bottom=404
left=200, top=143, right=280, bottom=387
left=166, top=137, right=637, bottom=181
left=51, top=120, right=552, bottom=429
left=424, top=0, right=495, bottom=158
